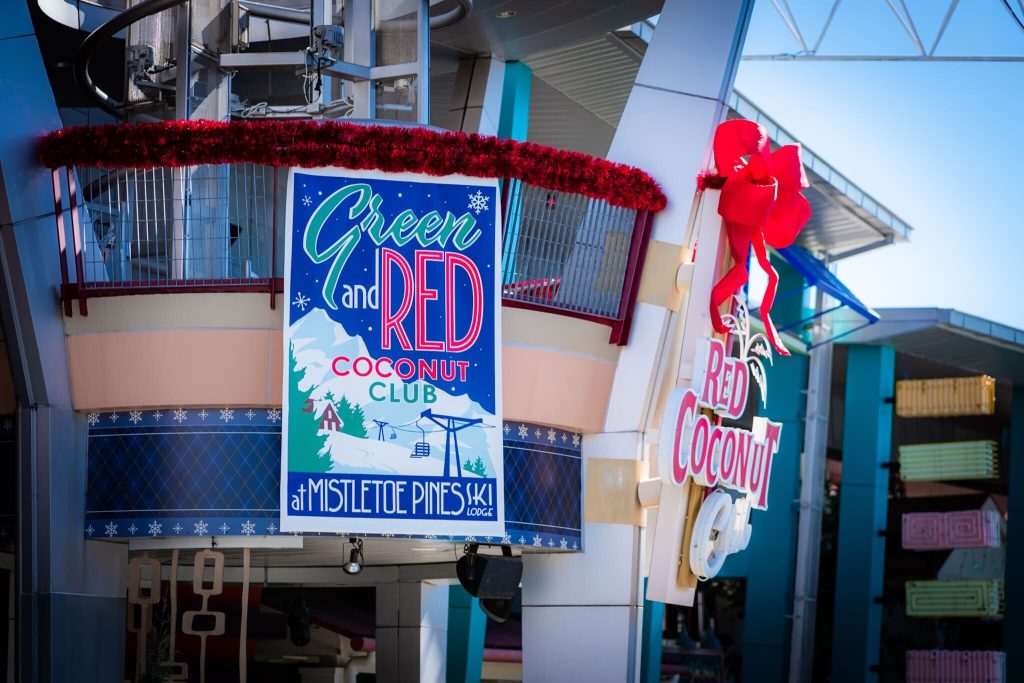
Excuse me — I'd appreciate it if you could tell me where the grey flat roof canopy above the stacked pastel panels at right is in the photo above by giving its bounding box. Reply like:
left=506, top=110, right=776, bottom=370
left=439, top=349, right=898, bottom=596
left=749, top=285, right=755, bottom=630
left=843, top=308, right=1024, bottom=386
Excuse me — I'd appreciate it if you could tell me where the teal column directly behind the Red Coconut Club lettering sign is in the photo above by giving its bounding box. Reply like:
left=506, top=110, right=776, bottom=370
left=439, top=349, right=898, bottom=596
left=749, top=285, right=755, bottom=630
left=720, top=355, right=808, bottom=681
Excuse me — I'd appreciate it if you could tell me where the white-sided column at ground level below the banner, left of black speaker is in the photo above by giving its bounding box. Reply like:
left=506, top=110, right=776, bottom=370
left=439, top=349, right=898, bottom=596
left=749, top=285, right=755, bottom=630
left=377, top=581, right=449, bottom=683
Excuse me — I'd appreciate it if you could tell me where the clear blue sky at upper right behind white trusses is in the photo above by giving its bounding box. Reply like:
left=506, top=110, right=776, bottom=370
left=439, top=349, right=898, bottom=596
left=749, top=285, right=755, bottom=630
left=736, top=0, right=1024, bottom=329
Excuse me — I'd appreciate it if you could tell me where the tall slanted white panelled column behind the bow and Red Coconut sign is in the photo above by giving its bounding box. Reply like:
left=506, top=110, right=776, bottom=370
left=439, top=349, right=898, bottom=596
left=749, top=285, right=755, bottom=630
left=523, top=0, right=754, bottom=682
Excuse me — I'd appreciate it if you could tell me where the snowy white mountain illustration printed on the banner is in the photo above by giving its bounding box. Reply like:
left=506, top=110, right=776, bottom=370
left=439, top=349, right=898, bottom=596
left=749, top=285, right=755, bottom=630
left=289, top=308, right=502, bottom=477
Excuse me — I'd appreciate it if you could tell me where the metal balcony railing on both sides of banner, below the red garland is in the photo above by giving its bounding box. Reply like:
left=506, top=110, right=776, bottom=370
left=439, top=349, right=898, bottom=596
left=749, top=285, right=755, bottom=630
left=53, top=163, right=653, bottom=344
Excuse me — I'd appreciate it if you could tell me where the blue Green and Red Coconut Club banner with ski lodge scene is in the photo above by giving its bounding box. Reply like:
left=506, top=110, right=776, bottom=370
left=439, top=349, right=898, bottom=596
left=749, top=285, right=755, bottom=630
left=281, top=169, right=505, bottom=536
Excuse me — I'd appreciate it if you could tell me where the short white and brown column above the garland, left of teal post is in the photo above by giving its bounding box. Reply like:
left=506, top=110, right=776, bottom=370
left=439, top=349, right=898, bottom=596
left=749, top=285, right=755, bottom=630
left=449, top=56, right=505, bottom=135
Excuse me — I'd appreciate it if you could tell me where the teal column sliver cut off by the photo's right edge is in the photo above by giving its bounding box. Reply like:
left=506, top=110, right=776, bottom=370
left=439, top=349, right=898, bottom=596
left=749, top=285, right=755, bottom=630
left=1002, top=387, right=1024, bottom=681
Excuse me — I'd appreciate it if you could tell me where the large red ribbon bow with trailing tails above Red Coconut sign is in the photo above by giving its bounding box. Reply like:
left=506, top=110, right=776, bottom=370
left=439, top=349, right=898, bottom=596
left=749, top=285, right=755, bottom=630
left=697, top=119, right=811, bottom=355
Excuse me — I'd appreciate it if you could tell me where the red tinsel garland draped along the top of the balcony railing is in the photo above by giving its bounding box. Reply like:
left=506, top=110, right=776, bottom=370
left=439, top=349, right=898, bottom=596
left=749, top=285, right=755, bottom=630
left=39, top=121, right=667, bottom=211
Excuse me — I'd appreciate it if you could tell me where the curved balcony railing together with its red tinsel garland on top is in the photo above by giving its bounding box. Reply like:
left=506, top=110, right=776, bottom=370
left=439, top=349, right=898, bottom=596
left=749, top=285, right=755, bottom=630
left=40, top=122, right=665, bottom=344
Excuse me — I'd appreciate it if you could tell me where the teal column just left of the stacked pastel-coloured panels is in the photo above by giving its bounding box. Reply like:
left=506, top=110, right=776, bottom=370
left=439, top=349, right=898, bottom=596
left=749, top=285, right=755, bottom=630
left=831, top=346, right=896, bottom=683
